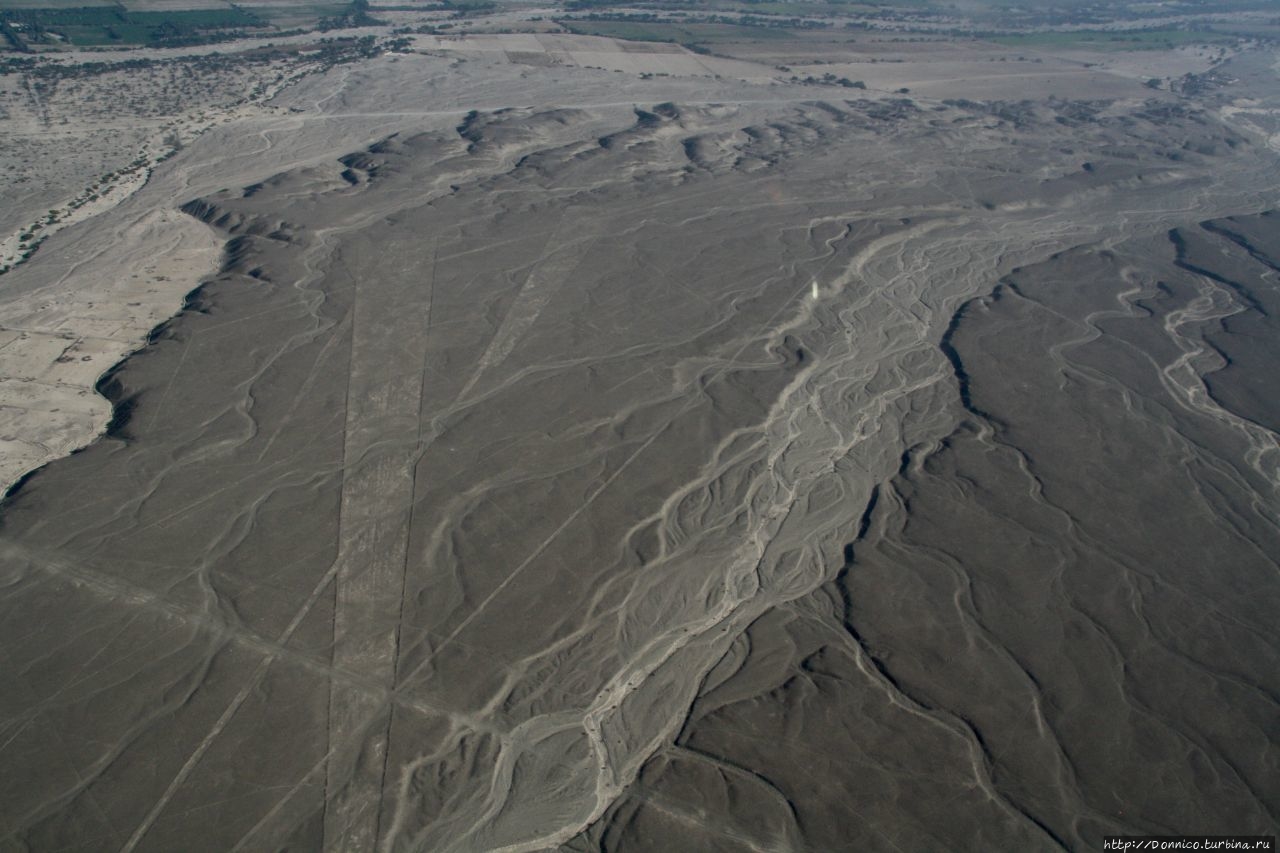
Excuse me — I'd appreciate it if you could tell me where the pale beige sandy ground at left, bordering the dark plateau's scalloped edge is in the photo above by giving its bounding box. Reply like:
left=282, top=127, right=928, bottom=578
left=0, top=51, right=360, bottom=489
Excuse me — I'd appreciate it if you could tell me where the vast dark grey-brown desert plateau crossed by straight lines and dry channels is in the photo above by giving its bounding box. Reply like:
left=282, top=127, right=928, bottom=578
left=0, top=92, right=1275, bottom=850
